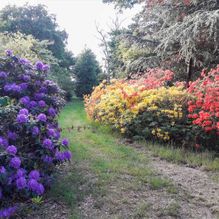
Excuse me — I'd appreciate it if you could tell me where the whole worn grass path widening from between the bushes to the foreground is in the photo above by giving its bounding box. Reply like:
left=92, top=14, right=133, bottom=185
left=29, top=101, right=219, bottom=219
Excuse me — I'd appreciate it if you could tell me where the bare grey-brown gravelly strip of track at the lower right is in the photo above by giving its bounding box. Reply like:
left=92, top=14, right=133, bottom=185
left=151, top=158, right=219, bottom=219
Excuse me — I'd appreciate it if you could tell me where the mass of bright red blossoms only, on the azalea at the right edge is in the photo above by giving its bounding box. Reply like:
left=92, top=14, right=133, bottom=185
left=188, top=66, right=219, bottom=136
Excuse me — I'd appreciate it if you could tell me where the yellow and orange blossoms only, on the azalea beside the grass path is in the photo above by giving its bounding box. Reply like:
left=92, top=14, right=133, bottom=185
left=85, top=80, right=188, bottom=141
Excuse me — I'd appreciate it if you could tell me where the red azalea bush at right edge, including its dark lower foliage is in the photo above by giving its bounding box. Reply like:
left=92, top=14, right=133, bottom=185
left=188, top=66, right=219, bottom=150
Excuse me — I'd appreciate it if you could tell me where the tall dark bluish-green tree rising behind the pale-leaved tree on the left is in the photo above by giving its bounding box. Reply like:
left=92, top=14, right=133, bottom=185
left=0, top=4, right=74, bottom=68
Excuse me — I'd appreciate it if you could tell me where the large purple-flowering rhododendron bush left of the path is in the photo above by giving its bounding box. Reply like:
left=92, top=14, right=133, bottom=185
left=0, top=50, right=71, bottom=218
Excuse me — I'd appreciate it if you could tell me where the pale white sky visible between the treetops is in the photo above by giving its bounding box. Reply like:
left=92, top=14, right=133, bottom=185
left=0, top=0, right=139, bottom=62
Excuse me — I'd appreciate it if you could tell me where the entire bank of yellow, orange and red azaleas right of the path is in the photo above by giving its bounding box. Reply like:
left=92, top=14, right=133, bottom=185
left=85, top=69, right=219, bottom=151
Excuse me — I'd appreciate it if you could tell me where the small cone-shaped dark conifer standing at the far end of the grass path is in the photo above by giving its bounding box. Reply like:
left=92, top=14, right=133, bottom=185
left=74, top=49, right=101, bottom=97
